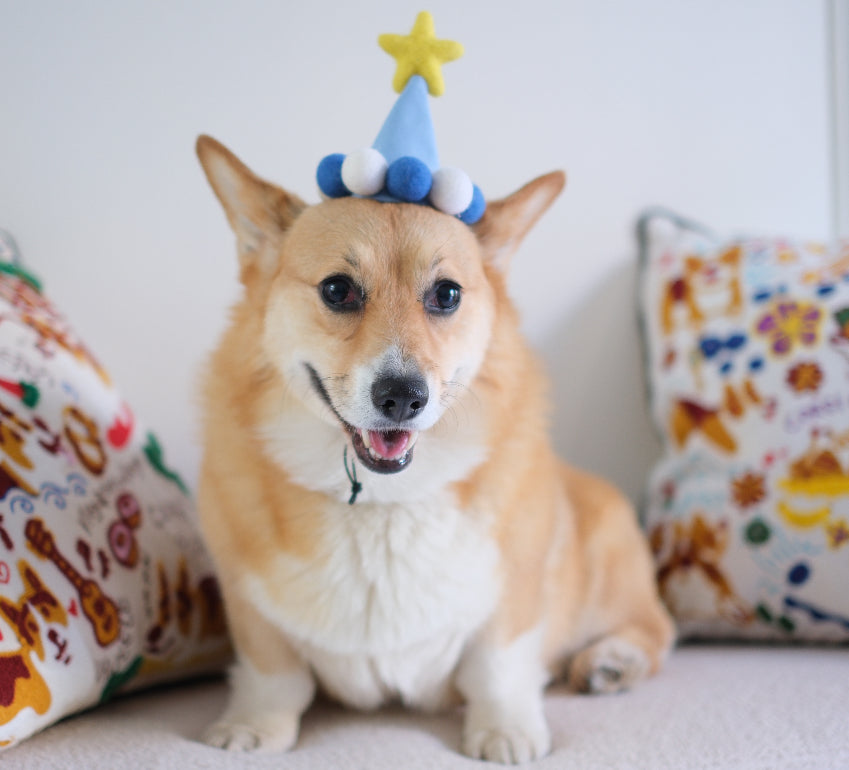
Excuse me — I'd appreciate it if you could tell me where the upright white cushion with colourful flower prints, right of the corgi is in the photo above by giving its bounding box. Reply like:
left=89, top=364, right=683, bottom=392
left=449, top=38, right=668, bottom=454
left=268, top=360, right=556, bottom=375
left=640, top=207, right=849, bottom=641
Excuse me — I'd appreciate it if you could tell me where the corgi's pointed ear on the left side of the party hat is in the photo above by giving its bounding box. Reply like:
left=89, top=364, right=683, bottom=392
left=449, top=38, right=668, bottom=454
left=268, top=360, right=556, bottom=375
left=196, top=136, right=306, bottom=282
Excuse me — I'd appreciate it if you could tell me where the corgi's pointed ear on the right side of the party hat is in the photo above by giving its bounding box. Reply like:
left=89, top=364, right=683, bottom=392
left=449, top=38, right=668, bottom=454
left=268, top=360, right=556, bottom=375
left=472, top=171, right=566, bottom=270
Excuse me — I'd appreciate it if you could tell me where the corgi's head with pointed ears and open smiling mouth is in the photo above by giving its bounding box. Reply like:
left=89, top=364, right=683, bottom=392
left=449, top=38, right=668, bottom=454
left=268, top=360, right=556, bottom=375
left=197, top=137, right=564, bottom=480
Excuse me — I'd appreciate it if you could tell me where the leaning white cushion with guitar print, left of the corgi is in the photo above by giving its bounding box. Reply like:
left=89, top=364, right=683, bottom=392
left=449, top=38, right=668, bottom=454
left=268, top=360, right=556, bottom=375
left=0, top=256, right=227, bottom=747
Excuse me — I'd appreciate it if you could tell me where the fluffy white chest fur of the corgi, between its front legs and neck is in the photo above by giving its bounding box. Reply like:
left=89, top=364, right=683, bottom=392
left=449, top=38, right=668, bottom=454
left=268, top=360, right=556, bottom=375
left=243, top=496, right=499, bottom=706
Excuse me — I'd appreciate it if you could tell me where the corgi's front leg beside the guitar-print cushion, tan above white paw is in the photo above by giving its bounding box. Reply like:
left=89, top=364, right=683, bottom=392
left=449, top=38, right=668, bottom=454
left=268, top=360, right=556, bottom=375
left=204, top=599, right=315, bottom=751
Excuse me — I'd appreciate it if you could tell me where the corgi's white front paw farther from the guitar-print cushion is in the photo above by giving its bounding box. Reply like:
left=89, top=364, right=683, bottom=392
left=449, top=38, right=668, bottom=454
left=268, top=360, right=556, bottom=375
left=463, top=709, right=551, bottom=765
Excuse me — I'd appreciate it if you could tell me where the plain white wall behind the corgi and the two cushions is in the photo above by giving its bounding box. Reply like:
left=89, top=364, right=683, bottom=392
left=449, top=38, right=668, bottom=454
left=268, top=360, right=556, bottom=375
left=0, top=0, right=834, bottom=496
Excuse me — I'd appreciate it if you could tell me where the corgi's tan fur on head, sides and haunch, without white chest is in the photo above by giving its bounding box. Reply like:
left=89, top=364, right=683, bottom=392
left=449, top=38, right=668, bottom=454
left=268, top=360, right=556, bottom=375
left=198, top=137, right=673, bottom=761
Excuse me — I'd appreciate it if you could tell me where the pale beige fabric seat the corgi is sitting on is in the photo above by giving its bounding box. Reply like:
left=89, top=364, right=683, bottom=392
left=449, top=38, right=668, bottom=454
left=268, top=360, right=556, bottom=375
left=8, top=646, right=849, bottom=770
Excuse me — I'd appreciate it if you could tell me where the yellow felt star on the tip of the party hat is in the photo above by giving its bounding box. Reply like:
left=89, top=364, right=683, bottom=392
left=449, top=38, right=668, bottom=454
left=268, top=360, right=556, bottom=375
left=377, top=11, right=463, bottom=96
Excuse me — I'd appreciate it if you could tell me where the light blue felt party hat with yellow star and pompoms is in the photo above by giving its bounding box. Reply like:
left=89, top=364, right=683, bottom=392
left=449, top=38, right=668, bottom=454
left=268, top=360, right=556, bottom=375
left=316, top=11, right=486, bottom=225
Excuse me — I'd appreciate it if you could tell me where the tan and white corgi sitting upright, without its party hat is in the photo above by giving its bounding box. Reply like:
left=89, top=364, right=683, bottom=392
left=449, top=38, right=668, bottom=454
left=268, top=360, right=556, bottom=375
left=197, top=136, right=673, bottom=763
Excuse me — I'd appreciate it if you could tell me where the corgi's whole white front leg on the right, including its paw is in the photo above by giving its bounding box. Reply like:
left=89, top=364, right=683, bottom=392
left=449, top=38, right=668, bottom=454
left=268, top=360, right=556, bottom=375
left=457, top=629, right=551, bottom=764
